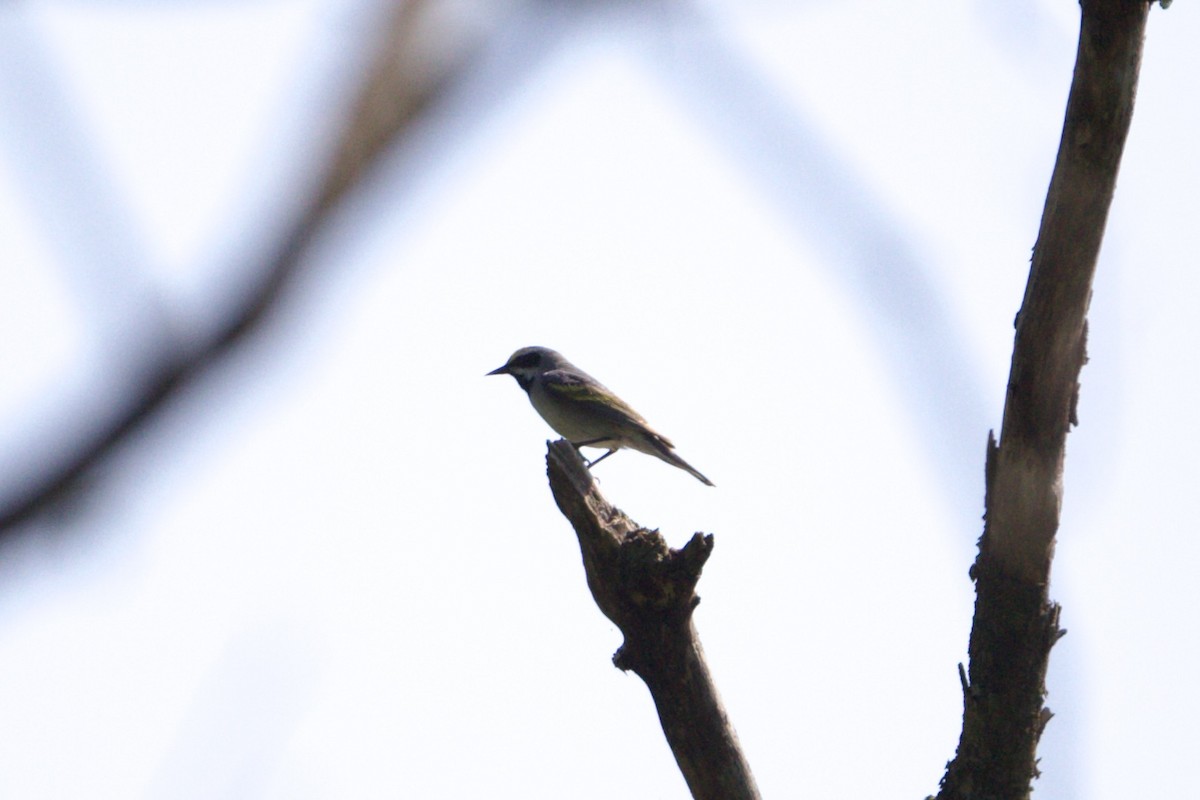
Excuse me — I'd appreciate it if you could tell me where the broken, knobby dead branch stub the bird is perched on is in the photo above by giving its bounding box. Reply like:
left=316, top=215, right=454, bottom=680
left=546, top=440, right=758, bottom=800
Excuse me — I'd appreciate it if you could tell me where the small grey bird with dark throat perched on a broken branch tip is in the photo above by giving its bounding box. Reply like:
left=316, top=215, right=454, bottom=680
left=487, top=347, right=714, bottom=486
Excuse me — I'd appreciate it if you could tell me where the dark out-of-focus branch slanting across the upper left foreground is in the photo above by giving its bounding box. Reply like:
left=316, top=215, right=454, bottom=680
left=0, top=0, right=450, bottom=535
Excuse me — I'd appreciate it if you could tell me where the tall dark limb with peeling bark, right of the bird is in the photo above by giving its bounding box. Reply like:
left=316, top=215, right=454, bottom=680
left=938, top=0, right=1148, bottom=800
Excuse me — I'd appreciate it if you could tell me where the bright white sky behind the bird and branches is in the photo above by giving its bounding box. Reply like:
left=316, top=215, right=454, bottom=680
left=0, top=0, right=1200, bottom=800
